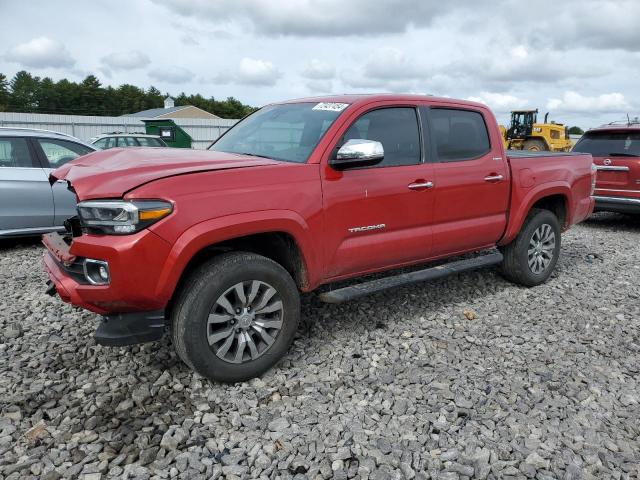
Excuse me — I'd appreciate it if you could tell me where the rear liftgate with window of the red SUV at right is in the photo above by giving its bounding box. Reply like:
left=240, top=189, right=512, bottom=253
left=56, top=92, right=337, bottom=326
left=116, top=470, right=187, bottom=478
left=573, top=128, right=640, bottom=198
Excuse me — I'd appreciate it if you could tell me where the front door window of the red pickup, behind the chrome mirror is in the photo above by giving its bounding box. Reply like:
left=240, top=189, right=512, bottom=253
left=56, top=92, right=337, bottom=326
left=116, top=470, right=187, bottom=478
left=343, top=107, right=420, bottom=167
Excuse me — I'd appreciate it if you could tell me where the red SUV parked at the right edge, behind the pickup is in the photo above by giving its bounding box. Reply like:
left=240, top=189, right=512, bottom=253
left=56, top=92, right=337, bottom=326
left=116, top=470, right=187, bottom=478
left=573, top=119, right=640, bottom=214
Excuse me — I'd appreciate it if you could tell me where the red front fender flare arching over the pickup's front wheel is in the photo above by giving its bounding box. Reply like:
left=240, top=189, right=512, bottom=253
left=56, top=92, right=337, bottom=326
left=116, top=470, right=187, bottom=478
left=155, top=210, right=320, bottom=301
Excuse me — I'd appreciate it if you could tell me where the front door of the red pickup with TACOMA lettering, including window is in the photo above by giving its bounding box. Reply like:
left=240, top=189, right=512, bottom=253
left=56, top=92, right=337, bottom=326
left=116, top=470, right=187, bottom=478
left=322, top=107, right=433, bottom=278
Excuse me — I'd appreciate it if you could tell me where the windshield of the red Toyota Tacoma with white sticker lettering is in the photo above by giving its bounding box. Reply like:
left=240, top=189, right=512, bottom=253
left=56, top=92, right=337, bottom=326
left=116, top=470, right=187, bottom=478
left=209, top=103, right=347, bottom=163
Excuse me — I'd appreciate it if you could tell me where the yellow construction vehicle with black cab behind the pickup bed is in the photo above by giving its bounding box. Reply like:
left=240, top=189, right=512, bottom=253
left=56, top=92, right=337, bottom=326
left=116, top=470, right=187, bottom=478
left=499, top=110, right=572, bottom=152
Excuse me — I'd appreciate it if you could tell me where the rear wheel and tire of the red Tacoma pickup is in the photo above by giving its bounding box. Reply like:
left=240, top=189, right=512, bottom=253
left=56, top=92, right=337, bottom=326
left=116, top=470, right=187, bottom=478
left=500, top=208, right=561, bottom=287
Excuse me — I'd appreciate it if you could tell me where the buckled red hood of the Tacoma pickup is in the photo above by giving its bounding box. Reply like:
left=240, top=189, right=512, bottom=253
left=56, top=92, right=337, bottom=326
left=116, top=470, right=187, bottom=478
left=50, top=148, right=282, bottom=200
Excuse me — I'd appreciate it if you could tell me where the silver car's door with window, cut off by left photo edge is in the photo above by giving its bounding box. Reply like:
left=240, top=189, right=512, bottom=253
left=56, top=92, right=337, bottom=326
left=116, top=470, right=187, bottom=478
left=0, top=137, right=54, bottom=234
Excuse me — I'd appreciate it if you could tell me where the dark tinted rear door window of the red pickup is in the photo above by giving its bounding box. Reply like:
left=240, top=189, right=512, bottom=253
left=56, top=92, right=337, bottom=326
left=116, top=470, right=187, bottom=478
left=429, top=108, right=491, bottom=162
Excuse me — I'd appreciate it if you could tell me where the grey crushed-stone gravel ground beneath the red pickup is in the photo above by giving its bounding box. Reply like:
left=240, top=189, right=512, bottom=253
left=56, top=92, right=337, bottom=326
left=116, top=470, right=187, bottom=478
left=0, top=214, right=640, bottom=479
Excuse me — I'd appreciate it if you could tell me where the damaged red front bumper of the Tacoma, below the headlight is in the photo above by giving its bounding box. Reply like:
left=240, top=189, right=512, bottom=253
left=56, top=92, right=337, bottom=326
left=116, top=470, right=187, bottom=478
left=42, top=231, right=168, bottom=346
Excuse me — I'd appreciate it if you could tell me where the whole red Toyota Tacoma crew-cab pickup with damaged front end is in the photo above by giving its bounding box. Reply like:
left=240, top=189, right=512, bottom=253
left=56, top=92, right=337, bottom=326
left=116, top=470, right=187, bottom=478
left=43, top=95, right=595, bottom=381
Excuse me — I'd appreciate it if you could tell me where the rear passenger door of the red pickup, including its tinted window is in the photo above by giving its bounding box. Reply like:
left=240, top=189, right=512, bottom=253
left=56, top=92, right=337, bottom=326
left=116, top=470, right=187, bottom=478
left=423, top=106, right=510, bottom=256
